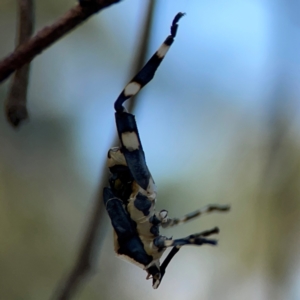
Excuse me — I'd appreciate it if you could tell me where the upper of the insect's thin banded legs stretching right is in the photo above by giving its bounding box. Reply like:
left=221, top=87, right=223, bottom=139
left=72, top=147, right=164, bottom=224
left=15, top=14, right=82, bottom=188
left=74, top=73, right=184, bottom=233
left=161, top=204, right=230, bottom=228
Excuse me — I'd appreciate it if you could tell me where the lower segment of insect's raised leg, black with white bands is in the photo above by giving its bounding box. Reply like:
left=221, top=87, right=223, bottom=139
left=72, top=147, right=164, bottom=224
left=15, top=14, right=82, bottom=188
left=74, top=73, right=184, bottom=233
left=115, top=13, right=184, bottom=112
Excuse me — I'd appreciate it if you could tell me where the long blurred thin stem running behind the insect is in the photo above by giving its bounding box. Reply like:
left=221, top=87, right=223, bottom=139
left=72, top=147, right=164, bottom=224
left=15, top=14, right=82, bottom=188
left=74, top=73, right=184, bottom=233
left=52, top=0, right=156, bottom=300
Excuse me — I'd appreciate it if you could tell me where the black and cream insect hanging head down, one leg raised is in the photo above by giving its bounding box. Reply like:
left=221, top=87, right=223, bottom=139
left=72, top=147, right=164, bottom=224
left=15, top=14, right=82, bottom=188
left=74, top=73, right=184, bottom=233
left=103, top=13, right=229, bottom=289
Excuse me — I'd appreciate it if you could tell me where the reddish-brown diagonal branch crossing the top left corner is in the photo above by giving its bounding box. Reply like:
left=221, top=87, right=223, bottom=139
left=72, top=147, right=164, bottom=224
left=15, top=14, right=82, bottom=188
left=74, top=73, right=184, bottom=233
left=0, top=0, right=120, bottom=82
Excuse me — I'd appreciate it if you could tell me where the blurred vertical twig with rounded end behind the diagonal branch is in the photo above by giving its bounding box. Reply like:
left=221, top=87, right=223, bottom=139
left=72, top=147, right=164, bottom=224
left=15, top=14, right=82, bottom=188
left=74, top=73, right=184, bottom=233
left=5, top=0, right=34, bottom=127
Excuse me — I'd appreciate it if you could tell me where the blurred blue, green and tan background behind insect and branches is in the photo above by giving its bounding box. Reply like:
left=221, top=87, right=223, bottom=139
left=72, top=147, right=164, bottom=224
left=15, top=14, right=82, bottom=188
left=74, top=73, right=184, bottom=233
left=0, top=0, right=300, bottom=300
